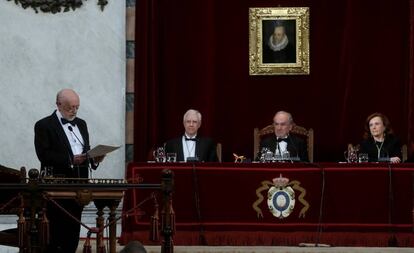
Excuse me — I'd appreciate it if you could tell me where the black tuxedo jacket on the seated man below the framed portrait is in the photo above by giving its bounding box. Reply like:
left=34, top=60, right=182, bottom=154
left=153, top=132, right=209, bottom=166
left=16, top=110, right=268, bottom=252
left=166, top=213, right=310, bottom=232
left=257, top=134, right=309, bottom=162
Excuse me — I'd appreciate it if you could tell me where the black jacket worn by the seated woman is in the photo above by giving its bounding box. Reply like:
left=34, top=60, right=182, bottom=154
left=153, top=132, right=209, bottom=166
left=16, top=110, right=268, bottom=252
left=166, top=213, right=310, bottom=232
left=359, top=134, right=402, bottom=162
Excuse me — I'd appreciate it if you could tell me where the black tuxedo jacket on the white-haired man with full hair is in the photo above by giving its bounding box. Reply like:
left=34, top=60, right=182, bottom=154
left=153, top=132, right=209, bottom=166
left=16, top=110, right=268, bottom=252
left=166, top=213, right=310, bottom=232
left=165, top=136, right=218, bottom=162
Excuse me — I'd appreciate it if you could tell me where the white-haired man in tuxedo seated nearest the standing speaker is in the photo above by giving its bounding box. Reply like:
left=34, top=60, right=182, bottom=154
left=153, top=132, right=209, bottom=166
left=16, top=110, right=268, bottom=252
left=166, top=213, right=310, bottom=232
left=165, top=109, right=218, bottom=162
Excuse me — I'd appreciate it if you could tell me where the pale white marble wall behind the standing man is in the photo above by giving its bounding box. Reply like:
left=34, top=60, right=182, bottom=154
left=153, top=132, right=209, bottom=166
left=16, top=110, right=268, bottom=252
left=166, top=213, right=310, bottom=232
left=0, top=0, right=126, bottom=178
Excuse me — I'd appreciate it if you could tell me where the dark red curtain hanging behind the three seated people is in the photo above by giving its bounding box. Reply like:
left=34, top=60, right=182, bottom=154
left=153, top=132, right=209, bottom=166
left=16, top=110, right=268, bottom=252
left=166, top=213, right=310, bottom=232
left=134, top=0, right=414, bottom=161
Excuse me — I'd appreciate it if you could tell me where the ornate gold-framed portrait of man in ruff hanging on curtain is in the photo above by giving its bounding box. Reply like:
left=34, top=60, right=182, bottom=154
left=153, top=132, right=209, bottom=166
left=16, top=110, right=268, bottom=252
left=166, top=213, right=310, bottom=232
left=249, top=7, right=310, bottom=75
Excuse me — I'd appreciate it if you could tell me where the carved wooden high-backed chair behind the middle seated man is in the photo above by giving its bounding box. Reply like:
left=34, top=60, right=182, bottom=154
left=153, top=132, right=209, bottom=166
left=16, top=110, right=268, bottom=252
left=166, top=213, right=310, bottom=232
left=253, top=125, right=313, bottom=163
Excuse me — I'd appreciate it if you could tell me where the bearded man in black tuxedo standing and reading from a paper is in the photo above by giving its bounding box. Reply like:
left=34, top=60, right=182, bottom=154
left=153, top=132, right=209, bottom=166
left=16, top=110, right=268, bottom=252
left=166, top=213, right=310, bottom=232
left=34, top=89, right=103, bottom=253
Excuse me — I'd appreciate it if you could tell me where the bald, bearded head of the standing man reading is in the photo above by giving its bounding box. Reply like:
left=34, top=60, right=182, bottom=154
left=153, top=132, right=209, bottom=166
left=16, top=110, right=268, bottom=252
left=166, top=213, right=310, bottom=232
left=56, top=89, right=80, bottom=120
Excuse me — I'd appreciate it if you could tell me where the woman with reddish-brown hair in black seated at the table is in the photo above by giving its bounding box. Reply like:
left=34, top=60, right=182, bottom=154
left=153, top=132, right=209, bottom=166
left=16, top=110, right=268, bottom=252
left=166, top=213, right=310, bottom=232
left=359, top=113, right=402, bottom=163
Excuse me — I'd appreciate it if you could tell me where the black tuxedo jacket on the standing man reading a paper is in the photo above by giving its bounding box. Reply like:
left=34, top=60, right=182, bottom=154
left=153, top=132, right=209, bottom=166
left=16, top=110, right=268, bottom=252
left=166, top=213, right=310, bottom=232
left=34, top=111, right=97, bottom=178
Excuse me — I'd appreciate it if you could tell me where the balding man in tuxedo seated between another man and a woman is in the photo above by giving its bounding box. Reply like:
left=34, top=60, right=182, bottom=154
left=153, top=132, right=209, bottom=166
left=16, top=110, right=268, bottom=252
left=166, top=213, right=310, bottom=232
left=258, top=111, right=308, bottom=162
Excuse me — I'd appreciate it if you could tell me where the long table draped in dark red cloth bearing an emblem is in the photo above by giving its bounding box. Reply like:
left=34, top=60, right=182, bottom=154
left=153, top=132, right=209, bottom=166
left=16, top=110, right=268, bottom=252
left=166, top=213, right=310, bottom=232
left=121, top=163, right=414, bottom=247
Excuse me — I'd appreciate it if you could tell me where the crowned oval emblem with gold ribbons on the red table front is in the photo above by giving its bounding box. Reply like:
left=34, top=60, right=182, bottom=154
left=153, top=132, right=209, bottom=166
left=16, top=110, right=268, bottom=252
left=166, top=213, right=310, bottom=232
left=252, top=175, right=309, bottom=219
